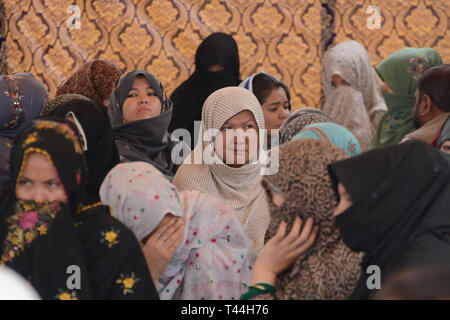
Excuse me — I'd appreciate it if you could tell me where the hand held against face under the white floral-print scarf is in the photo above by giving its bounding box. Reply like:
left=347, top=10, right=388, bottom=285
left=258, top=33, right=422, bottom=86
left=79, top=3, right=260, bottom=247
left=141, top=215, right=184, bottom=286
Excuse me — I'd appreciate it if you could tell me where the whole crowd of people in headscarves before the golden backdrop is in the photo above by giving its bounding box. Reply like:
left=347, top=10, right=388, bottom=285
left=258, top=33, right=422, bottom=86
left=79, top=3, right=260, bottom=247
left=0, top=33, right=450, bottom=300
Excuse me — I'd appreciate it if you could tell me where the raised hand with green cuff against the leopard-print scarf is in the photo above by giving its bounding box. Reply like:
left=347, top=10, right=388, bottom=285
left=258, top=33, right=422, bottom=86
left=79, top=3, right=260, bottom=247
left=251, top=217, right=319, bottom=285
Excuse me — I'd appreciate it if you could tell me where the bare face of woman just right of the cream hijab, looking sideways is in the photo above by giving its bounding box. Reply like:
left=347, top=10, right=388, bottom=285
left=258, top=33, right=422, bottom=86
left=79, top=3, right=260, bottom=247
left=261, top=87, right=289, bottom=136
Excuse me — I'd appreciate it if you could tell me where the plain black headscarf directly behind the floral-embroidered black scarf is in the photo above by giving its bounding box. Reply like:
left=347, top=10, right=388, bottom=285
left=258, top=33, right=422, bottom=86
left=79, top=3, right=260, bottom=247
left=48, top=98, right=120, bottom=202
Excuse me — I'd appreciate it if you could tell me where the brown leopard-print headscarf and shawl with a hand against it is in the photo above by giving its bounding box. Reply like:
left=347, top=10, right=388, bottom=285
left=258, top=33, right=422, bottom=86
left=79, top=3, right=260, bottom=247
left=263, top=139, right=362, bottom=300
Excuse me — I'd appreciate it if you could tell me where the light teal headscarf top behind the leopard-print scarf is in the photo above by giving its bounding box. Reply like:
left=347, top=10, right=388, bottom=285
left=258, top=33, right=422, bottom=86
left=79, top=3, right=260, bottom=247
left=292, top=122, right=361, bottom=157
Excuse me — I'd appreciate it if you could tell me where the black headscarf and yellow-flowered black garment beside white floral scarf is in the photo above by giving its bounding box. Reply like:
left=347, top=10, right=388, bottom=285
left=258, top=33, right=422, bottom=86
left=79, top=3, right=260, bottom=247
left=40, top=110, right=158, bottom=300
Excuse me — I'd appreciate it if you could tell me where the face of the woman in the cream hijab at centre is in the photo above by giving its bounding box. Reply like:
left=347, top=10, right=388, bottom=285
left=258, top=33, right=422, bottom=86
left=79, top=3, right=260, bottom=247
left=215, top=110, right=259, bottom=168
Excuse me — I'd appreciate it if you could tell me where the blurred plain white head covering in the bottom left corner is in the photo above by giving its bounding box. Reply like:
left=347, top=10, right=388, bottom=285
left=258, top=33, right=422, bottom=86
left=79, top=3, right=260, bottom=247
left=0, top=266, right=41, bottom=300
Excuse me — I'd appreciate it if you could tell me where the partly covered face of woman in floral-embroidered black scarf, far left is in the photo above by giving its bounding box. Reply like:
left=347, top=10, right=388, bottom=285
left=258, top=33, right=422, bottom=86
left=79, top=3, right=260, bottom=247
left=16, top=152, right=68, bottom=203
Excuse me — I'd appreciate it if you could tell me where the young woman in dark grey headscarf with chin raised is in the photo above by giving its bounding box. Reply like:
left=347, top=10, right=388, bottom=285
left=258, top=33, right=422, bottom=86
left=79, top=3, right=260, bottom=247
left=108, top=70, right=182, bottom=180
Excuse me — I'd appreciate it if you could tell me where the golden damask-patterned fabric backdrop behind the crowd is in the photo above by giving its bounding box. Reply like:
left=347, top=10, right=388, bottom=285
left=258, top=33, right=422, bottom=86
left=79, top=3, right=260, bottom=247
left=0, top=0, right=450, bottom=109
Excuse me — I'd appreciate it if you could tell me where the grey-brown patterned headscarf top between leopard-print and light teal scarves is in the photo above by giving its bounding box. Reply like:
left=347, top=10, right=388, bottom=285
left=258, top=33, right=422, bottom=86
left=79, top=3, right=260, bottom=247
left=280, top=108, right=333, bottom=144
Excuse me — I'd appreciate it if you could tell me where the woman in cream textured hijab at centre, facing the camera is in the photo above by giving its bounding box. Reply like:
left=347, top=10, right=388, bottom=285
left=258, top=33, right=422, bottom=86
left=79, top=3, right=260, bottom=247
left=173, top=87, right=270, bottom=250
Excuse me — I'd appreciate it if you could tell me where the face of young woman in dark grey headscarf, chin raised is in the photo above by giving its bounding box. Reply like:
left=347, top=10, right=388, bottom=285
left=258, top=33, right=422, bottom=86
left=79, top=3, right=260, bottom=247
left=122, top=77, right=161, bottom=122
